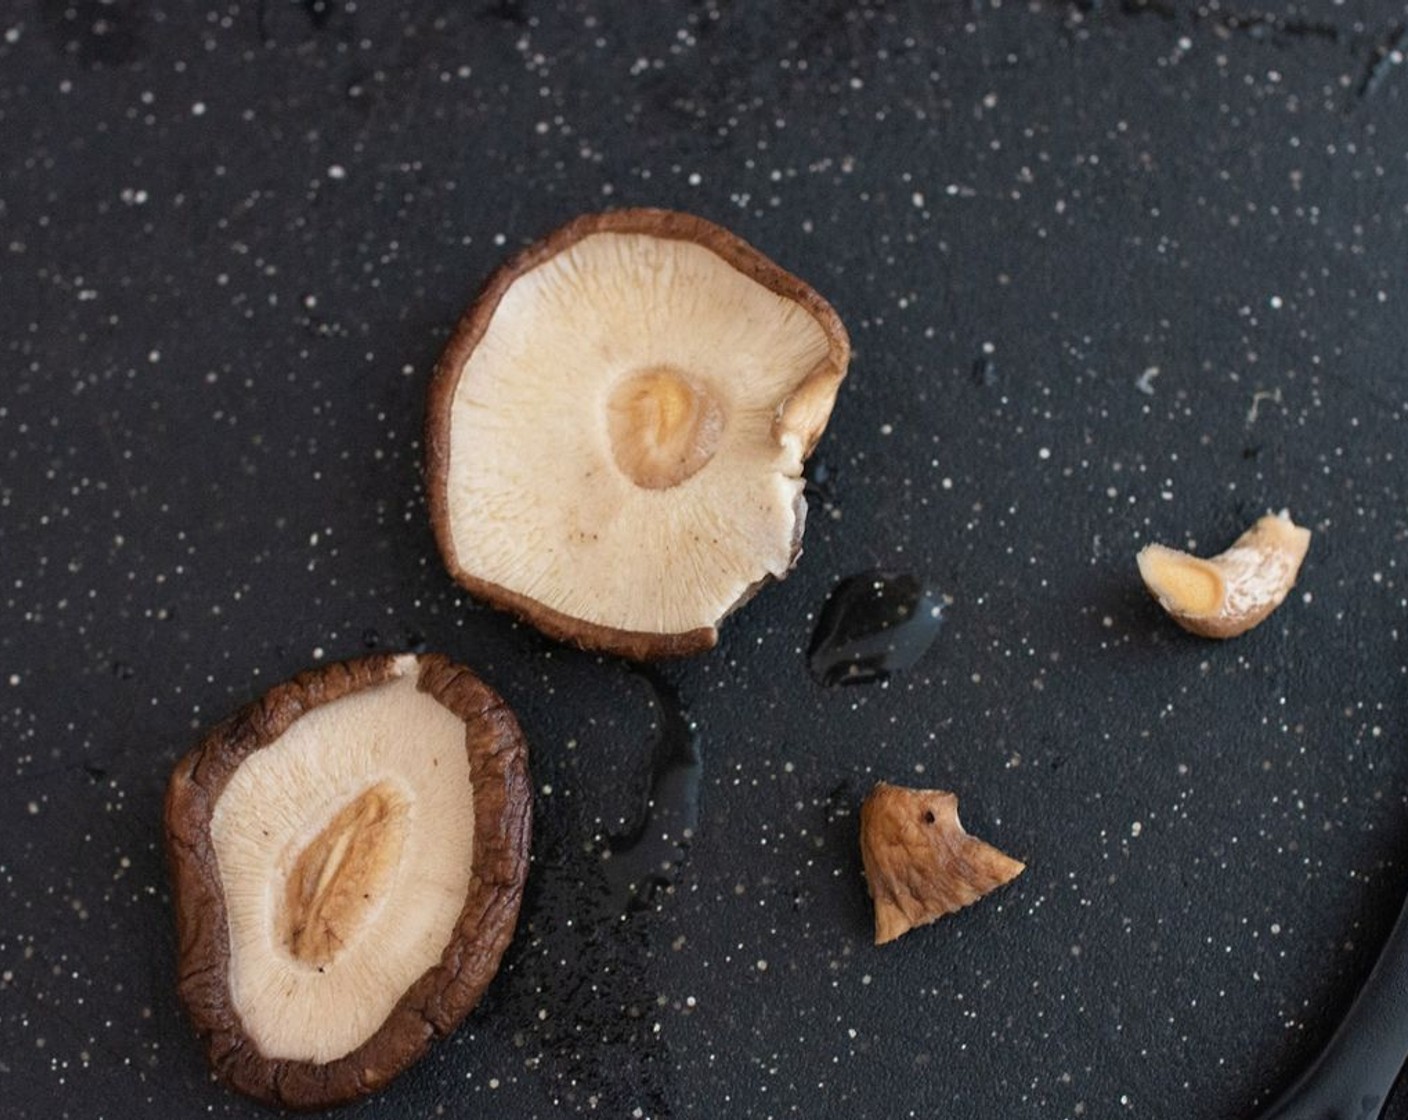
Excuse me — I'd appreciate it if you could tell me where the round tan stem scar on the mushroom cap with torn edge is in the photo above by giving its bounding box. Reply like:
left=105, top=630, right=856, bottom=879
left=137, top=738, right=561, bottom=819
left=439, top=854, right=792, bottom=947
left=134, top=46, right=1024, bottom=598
left=607, top=366, right=724, bottom=490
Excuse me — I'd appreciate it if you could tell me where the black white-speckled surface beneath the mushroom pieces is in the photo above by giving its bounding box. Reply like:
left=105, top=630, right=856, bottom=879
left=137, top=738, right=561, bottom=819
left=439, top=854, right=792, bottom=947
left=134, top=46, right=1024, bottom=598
left=0, top=0, right=1408, bottom=1120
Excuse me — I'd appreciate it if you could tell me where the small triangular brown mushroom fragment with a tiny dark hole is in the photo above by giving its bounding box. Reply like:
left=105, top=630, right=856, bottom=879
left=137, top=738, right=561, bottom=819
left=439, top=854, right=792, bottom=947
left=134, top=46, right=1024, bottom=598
left=860, top=782, right=1026, bottom=945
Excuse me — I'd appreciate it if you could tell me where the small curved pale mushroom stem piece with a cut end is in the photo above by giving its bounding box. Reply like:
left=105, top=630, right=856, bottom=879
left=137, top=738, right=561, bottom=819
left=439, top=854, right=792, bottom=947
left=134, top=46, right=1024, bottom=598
left=1138, top=510, right=1311, bottom=638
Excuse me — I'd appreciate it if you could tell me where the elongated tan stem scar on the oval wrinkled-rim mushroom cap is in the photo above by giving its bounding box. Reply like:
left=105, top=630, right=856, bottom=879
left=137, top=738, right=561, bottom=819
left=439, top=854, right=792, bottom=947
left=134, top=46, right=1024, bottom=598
left=277, top=782, right=410, bottom=968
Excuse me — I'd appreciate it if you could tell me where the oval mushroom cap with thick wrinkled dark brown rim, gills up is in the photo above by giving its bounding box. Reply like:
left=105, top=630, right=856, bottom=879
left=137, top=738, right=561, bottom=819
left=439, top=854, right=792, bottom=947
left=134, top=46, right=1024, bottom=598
left=166, top=655, right=532, bottom=1109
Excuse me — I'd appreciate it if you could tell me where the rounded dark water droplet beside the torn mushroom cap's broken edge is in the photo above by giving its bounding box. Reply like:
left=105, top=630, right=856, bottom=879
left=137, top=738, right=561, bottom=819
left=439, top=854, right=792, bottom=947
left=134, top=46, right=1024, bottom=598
left=807, top=571, right=950, bottom=686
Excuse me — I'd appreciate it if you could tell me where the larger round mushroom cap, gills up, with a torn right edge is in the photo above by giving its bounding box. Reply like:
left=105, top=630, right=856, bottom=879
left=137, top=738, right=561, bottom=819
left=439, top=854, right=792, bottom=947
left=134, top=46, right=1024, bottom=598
left=425, top=210, right=850, bottom=658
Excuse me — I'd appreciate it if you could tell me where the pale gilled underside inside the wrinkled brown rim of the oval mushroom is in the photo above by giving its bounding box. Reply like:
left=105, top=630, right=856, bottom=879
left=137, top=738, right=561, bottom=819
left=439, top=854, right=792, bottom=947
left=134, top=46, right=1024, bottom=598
left=211, top=658, right=474, bottom=1062
